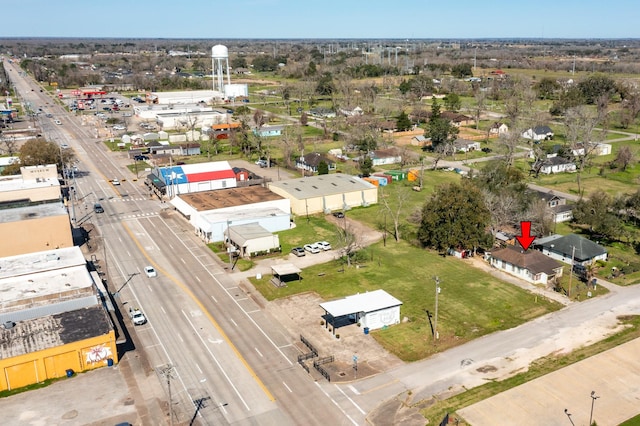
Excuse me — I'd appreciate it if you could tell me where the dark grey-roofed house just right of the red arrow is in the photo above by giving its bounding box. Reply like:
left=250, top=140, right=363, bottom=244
left=533, top=234, right=607, bottom=266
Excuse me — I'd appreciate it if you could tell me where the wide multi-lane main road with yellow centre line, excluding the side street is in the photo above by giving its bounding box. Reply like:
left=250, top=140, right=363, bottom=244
left=5, top=58, right=364, bottom=425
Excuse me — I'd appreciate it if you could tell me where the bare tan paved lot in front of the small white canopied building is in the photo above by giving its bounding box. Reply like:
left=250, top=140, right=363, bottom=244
left=267, top=293, right=403, bottom=381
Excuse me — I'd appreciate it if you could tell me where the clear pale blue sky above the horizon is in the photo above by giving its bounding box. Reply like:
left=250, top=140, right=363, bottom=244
left=5, top=0, right=640, bottom=39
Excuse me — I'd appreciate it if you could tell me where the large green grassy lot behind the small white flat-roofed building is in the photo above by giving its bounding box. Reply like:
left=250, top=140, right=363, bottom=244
left=252, top=241, right=560, bottom=361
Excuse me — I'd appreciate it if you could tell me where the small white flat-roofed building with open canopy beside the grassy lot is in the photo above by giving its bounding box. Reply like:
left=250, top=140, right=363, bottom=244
left=320, top=290, right=402, bottom=334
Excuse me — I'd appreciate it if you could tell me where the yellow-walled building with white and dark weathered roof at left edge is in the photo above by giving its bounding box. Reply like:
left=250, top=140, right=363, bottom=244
left=0, top=247, right=117, bottom=390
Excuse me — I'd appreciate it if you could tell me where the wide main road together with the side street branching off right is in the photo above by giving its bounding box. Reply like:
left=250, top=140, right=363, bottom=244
left=5, top=57, right=640, bottom=425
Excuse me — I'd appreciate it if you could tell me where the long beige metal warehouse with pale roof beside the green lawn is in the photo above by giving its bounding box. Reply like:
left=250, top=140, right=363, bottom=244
left=269, top=173, right=378, bottom=216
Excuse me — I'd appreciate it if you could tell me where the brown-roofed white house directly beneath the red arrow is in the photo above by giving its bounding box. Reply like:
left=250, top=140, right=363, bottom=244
left=489, top=246, right=562, bottom=285
